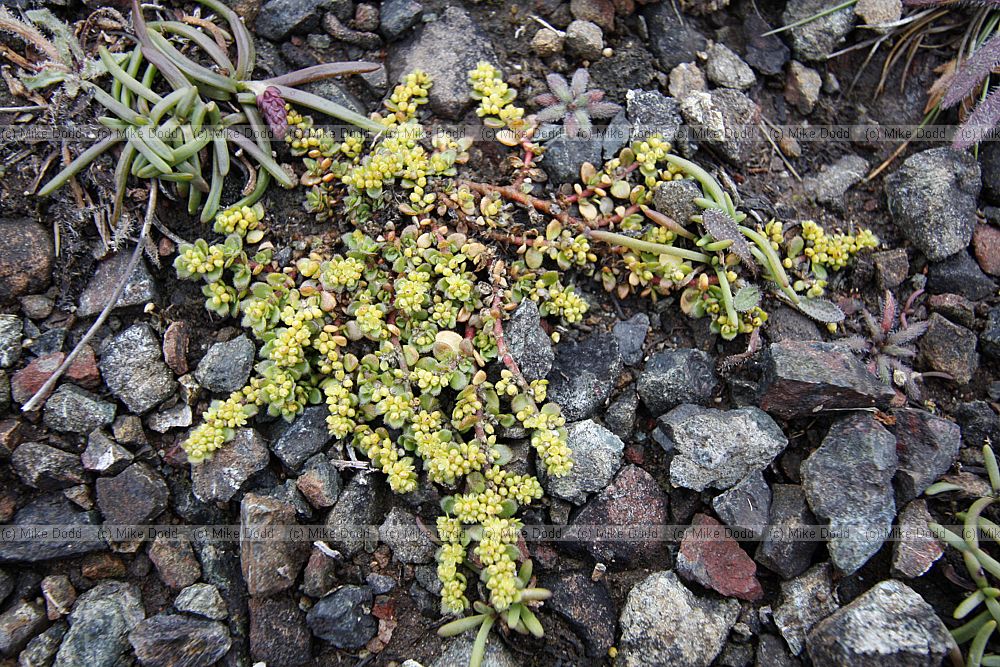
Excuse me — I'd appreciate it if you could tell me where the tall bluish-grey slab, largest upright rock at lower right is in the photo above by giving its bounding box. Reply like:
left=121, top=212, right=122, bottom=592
left=801, top=413, right=898, bottom=574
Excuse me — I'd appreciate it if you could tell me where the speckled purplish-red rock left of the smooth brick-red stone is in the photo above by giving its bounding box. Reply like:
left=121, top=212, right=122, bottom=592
left=563, top=465, right=669, bottom=569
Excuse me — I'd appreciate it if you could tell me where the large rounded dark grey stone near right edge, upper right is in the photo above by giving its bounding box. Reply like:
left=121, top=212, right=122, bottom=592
left=888, top=148, right=982, bottom=262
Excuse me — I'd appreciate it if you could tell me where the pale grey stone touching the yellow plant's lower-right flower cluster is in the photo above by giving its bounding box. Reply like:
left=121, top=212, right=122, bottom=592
left=545, top=419, right=625, bottom=505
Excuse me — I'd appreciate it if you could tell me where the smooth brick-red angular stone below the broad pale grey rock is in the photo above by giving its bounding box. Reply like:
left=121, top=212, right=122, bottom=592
left=677, top=514, right=764, bottom=601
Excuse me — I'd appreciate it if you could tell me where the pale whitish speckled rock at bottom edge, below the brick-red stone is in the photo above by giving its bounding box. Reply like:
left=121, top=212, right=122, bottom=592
left=618, top=572, right=740, bottom=667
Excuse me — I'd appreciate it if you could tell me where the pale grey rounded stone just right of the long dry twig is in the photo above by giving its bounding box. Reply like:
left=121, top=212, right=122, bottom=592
left=99, top=324, right=177, bottom=414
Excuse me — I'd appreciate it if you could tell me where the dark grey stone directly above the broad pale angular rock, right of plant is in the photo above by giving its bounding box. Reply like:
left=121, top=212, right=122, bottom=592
left=636, top=349, right=719, bottom=416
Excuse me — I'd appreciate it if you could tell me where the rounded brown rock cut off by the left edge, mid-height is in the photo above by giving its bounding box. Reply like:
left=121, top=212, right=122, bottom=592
left=0, top=220, right=55, bottom=303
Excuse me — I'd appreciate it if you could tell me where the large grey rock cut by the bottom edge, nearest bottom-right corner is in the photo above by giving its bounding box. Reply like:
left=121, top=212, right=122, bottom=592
left=806, top=579, right=954, bottom=667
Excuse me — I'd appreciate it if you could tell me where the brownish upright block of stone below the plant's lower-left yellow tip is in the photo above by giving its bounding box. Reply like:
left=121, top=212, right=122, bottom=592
left=240, top=493, right=306, bottom=597
